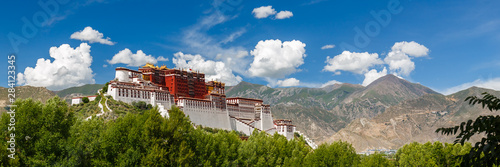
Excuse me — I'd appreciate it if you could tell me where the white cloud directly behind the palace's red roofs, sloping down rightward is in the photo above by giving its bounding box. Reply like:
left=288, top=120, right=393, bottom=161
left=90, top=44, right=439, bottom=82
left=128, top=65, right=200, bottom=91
left=172, top=52, right=243, bottom=86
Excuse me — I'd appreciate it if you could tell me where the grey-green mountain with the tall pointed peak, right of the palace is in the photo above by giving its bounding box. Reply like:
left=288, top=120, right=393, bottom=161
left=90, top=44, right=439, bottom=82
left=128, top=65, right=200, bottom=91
left=226, top=75, right=438, bottom=141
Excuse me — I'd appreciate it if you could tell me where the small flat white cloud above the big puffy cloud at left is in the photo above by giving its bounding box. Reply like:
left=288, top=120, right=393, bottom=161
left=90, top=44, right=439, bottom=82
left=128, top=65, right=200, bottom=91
left=70, top=26, right=115, bottom=45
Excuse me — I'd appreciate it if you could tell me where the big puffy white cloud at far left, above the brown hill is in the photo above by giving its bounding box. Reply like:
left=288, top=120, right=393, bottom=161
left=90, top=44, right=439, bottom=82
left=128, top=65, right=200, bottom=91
left=17, top=43, right=95, bottom=90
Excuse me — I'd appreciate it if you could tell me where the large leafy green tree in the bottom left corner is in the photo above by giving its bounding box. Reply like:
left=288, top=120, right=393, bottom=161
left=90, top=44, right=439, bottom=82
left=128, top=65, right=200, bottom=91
left=0, top=96, right=75, bottom=166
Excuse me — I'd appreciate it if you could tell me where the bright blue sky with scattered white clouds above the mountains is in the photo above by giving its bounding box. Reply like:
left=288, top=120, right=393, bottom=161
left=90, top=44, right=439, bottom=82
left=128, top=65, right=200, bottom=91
left=0, top=0, right=500, bottom=94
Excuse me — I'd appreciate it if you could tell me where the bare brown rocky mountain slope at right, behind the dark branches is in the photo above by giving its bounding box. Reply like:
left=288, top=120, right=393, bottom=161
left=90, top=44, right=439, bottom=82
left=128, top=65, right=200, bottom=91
left=325, top=87, right=500, bottom=151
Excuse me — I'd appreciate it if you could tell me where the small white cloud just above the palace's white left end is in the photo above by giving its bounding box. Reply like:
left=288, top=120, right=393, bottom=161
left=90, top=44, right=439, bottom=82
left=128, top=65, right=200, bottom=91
left=107, top=48, right=168, bottom=67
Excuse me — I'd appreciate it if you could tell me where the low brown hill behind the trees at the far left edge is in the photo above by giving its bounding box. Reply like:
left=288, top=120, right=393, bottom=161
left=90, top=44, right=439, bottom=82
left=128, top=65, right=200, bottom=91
left=0, top=86, right=56, bottom=112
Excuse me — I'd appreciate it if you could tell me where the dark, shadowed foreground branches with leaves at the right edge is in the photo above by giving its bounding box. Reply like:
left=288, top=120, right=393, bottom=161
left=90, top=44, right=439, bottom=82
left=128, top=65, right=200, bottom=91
left=436, top=92, right=500, bottom=166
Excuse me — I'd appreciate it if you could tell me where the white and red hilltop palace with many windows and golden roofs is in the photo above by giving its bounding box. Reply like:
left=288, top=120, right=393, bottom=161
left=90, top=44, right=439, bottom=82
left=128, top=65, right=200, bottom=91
left=103, top=63, right=295, bottom=140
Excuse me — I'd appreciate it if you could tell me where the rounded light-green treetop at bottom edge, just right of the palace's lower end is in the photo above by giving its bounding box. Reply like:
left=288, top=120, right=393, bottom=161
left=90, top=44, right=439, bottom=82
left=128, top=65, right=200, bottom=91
left=304, top=141, right=360, bottom=166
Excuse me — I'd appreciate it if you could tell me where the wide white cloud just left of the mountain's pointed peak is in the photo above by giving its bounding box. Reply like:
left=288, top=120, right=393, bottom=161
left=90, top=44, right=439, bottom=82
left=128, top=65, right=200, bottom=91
left=323, top=51, right=383, bottom=74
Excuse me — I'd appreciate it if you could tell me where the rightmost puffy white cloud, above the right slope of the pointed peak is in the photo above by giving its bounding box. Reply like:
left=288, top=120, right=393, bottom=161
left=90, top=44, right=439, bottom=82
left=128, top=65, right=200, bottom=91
left=384, top=41, right=429, bottom=76
